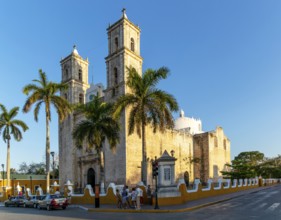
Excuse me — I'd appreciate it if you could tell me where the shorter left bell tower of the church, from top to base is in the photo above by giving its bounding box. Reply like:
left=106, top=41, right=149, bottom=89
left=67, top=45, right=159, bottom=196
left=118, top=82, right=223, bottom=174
left=59, top=46, right=89, bottom=186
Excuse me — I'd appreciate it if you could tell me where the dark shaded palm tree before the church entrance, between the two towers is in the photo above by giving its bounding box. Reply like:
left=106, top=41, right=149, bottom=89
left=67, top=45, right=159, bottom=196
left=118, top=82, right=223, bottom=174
left=72, top=96, right=120, bottom=186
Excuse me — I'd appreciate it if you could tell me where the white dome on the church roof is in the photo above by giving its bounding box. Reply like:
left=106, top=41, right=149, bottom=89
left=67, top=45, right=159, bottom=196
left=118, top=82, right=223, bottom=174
left=174, top=110, right=203, bottom=134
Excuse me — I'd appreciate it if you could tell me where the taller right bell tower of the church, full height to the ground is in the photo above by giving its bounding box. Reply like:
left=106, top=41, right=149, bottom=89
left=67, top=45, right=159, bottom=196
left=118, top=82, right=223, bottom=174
left=104, top=9, right=143, bottom=184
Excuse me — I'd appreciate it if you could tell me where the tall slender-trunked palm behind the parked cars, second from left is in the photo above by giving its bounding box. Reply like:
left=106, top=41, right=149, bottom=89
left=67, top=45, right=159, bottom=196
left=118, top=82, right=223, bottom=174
left=23, top=69, right=71, bottom=192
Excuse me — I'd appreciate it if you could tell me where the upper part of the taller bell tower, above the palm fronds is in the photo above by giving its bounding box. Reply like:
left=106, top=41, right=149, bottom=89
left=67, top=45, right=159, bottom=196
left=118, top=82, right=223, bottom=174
left=105, top=9, right=143, bottom=101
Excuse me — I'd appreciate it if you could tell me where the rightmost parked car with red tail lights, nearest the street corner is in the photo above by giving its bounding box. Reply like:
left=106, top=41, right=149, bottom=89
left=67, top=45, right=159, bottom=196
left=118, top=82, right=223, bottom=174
left=37, top=194, right=68, bottom=211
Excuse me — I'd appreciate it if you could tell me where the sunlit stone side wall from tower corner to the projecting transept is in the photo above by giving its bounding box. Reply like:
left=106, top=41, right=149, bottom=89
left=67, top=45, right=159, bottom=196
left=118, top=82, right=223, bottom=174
left=123, top=127, right=193, bottom=184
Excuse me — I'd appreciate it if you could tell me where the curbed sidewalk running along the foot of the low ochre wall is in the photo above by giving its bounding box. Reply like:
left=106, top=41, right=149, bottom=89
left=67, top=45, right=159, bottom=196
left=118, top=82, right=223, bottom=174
left=70, top=184, right=279, bottom=213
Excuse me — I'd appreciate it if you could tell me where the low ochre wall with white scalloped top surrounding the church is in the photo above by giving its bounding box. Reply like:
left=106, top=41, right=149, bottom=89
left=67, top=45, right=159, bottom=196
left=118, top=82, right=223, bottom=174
left=67, top=178, right=280, bottom=206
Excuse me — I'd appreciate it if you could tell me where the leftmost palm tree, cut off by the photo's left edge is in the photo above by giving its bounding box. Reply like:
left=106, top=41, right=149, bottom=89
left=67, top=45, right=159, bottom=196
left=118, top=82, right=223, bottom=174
left=0, top=104, right=28, bottom=186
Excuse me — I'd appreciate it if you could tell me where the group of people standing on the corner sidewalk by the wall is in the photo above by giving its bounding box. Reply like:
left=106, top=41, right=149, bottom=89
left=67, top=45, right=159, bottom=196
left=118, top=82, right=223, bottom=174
left=116, top=186, right=143, bottom=210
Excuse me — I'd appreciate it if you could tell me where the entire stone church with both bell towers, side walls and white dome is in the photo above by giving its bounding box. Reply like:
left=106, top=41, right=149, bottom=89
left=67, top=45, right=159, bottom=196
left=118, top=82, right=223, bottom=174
left=59, top=11, right=230, bottom=188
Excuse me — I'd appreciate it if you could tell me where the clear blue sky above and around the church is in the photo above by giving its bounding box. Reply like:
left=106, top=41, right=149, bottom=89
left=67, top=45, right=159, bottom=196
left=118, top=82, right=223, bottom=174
left=0, top=0, right=281, bottom=168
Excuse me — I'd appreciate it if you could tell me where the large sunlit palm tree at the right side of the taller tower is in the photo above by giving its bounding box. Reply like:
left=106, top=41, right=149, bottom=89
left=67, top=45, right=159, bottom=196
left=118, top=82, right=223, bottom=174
left=113, top=67, right=178, bottom=184
